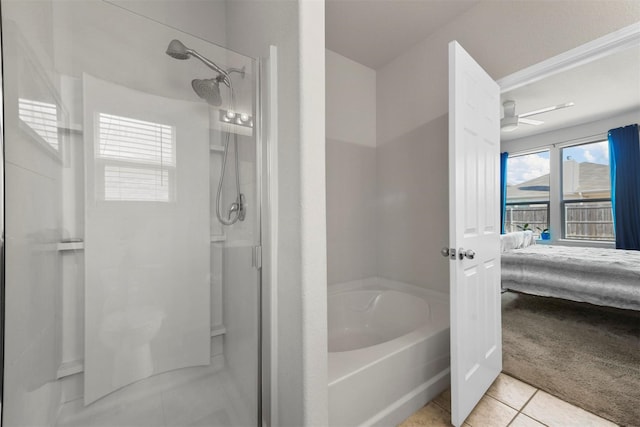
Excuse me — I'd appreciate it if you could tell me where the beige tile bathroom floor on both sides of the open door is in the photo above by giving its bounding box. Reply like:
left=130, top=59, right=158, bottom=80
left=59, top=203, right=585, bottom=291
left=399, top=374, right=616, bottom=427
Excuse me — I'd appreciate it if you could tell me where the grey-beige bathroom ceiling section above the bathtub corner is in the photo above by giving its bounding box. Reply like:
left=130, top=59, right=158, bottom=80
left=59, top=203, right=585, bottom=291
left=325, top=0, right=479, bottom=69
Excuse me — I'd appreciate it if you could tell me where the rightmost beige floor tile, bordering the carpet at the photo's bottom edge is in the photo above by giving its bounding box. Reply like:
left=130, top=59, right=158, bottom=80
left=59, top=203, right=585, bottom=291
left=522, top=391, right=615, bottom=427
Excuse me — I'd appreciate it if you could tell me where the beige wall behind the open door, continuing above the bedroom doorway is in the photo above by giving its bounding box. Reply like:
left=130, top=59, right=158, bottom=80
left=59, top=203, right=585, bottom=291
left=377, top=0, right=640, bottom=291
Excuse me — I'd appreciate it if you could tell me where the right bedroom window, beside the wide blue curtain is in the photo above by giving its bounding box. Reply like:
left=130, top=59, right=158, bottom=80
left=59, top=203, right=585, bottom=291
left=561, top=140, right=615, bottom=241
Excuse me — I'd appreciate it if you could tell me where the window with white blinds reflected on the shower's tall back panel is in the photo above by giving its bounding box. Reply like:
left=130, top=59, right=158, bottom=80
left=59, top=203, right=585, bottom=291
left=96, top=113, right=176, bottom=202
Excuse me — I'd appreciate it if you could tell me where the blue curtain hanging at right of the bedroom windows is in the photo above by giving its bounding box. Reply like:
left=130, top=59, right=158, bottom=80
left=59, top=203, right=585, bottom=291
left=609, top=124, right=640, bottom=250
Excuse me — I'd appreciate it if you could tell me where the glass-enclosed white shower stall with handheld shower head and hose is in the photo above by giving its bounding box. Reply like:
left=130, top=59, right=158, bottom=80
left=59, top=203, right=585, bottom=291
left=1, top=0, right=263, bottom=427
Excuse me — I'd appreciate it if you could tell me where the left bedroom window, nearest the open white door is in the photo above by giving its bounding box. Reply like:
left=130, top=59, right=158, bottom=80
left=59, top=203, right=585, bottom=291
left=505, top=150, right=550, bottom=237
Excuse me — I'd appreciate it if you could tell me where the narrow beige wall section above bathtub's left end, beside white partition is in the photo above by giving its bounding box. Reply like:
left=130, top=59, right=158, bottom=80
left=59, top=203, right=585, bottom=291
left=326, top=50, right=378, bottom=284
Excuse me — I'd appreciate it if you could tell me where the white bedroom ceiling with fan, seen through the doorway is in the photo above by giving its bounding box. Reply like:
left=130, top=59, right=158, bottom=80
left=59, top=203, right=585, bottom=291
left=501, top=46, right=640, bottom=141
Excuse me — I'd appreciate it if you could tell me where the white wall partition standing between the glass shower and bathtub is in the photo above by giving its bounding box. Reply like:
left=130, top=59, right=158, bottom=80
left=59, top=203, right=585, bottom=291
left=227, top=0, right=328, bottom=426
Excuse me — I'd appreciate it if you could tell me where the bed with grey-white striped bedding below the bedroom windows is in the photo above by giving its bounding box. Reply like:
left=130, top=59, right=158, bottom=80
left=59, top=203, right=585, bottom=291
left=501, top=233, right=640, bottom=310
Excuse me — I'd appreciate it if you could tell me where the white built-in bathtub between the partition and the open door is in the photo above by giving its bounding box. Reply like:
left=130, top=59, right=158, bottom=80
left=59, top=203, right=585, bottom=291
left=328, top=278, right=449, bottom=427
